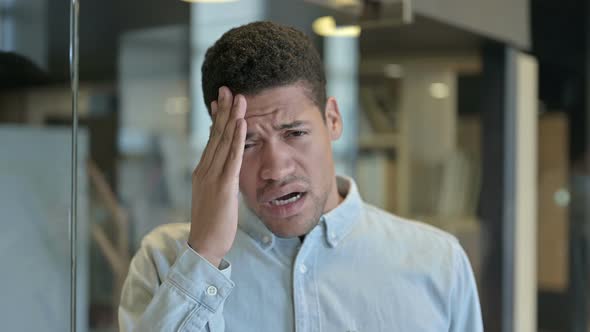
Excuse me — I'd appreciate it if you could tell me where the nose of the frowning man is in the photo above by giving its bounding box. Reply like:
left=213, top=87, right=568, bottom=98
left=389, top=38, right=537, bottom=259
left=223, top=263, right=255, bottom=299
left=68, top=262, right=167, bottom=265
left=259, top=142, right=295, bottom=181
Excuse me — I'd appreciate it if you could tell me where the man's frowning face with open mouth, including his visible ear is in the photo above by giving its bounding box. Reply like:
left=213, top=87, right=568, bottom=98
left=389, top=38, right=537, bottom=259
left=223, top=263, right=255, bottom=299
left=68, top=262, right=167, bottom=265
left=240, top=84, right=342, bottom=237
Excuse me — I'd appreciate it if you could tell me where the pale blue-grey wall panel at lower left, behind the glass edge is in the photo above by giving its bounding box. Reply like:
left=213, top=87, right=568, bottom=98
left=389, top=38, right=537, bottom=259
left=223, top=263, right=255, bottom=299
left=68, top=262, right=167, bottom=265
left=0, top=126, right=90, bottom=332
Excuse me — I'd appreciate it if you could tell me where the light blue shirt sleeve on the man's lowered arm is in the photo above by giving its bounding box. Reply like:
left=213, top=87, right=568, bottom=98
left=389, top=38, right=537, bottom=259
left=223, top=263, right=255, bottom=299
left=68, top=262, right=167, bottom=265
left=450, top=243, right=483, bottom=332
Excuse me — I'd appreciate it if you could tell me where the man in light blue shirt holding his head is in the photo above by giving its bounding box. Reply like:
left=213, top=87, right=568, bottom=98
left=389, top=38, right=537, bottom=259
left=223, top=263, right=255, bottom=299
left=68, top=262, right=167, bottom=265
left=119, top=22, right=482, bottom=332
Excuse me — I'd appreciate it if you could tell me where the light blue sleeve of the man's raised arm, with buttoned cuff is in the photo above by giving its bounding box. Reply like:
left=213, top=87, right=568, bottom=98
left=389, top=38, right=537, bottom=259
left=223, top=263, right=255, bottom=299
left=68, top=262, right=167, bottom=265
left=119, top=241, right=235, bottom=332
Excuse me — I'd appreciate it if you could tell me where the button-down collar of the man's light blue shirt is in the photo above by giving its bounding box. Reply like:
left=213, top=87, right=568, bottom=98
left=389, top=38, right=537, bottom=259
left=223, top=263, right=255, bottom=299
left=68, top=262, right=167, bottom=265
left=239, top=176, right=362, bottom=250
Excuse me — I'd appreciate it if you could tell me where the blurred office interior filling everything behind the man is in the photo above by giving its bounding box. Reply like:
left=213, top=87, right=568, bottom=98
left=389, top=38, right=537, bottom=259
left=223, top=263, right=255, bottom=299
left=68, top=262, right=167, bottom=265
left=0, top=0, right=590, bottom=332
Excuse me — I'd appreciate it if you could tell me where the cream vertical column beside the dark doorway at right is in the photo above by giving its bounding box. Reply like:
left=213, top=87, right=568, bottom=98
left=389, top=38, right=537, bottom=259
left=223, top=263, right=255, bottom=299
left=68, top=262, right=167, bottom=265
left=504, top=49, right=538, bottom=332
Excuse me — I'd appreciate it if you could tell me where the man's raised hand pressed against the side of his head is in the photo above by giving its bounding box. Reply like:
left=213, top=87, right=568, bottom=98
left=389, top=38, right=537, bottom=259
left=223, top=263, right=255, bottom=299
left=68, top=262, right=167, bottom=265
left=188, top=87, right=246, bottom=267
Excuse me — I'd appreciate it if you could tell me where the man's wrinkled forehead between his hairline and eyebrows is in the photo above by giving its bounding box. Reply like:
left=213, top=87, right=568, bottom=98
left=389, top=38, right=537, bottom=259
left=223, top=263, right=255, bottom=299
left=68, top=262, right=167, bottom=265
left=245, top=84, right=319, bottom=123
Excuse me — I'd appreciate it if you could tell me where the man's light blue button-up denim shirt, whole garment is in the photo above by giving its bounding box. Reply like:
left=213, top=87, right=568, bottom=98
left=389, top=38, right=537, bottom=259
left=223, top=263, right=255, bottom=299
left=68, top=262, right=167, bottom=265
left=119, top=177, right=483, bottom=332
